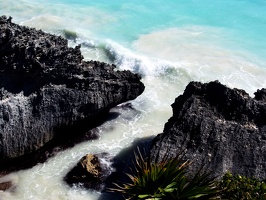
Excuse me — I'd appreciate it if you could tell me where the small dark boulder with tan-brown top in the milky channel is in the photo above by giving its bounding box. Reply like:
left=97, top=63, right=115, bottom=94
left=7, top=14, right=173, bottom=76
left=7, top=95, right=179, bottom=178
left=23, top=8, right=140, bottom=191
left=64, top=154, right=111, bottom=191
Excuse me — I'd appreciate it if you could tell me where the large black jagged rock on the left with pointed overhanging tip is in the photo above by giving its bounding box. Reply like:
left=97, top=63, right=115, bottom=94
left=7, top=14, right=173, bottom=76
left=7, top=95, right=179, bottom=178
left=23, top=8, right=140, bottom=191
left=0, top=16, right=144, bottom=163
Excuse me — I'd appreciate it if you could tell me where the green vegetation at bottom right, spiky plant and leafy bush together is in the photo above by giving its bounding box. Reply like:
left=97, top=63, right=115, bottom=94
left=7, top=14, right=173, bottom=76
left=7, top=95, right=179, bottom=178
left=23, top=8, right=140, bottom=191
left=109, top=146, right=266, bottom=200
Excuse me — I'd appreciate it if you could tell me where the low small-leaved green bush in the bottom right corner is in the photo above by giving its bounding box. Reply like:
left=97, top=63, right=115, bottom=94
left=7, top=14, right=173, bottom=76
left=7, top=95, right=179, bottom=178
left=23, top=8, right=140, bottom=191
left=218, top=172, right=266, bottom=200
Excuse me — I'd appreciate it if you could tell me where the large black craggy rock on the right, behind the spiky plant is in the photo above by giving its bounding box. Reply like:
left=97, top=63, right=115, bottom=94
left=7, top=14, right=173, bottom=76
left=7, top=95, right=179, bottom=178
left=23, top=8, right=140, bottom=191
left=150, top=81, right=266, bottom=179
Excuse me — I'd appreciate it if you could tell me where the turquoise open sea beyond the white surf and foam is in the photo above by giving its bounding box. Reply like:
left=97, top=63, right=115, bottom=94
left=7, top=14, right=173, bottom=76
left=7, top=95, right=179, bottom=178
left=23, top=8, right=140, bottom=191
left=3, top=0, right=266, bottom=57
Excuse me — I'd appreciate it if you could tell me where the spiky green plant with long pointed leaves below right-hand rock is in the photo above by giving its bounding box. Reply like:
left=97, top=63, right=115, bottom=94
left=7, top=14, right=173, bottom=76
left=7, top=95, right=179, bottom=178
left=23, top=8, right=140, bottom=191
left=110, top=149, right=219, bottom=200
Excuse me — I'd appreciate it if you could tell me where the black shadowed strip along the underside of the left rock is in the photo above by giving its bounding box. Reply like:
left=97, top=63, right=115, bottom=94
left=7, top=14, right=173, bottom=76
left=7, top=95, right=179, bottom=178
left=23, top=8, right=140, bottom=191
left=0, top=112, right=120, bottom=177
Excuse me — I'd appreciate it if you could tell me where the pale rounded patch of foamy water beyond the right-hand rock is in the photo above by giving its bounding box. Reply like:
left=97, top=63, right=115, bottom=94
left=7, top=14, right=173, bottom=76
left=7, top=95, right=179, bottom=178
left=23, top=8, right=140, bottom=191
left=133, top=26, right=266, bottom=93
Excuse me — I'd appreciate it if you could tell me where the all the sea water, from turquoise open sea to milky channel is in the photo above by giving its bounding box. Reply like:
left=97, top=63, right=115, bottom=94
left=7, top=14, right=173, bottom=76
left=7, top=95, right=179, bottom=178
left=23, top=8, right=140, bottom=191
left=0, top=0, right=266, bottom=200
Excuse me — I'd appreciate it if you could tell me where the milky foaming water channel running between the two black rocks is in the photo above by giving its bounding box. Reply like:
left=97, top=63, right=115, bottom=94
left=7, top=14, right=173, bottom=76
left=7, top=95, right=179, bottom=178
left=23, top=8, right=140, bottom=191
left=0, top=74, right=179, bottom=200
